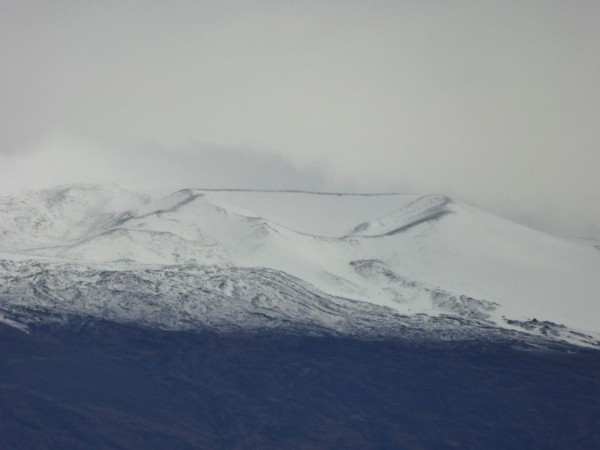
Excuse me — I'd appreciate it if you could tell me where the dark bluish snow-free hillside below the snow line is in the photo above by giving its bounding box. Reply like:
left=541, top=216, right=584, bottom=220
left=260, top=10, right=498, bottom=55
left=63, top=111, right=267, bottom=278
left=0, top=322, right=600, bottom=450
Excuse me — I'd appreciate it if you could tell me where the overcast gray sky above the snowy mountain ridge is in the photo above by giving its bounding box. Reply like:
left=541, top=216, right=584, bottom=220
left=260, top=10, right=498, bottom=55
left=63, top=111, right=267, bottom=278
left=0, top=0, right=600, bottom=237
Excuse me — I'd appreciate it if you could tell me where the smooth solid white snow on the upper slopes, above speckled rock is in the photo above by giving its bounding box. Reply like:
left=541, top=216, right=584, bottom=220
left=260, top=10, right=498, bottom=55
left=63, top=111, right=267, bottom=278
left=0, top=186, right=600, bottom=342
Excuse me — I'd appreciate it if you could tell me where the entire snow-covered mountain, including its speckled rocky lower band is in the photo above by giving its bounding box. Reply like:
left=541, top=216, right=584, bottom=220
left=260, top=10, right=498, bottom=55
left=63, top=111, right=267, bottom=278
left=0, top=186, right=600, bottom=346
